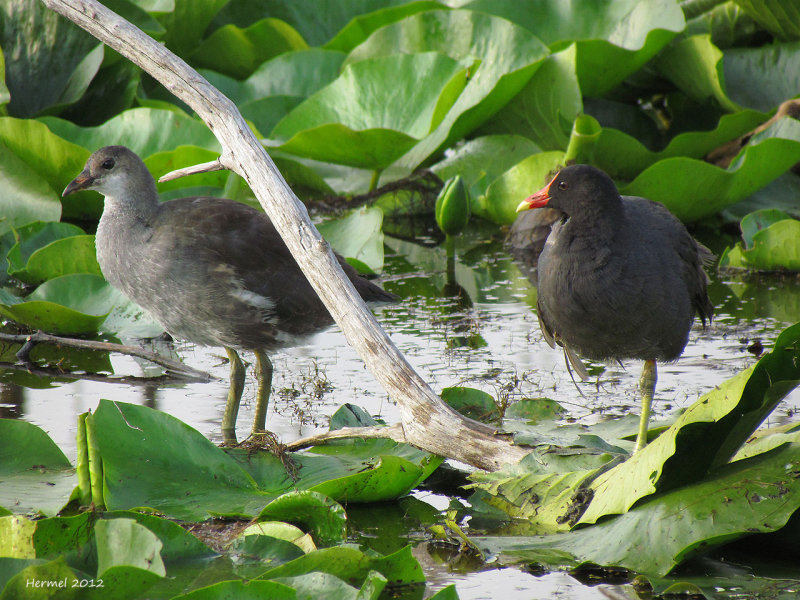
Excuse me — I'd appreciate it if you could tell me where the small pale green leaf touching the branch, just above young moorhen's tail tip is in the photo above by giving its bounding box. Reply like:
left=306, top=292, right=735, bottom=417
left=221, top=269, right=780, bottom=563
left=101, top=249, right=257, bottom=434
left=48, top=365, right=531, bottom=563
left=317, top=207, right=383, bottom=272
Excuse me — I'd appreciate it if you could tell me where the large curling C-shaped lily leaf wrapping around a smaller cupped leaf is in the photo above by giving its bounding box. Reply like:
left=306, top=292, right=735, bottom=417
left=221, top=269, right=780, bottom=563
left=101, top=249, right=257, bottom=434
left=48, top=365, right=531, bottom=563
left=347, top=10, right=548, bottom=180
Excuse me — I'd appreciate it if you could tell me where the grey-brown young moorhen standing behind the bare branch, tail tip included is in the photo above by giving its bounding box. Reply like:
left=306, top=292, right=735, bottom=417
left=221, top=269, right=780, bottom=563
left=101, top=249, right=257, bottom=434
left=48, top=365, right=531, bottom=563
left=63, top=146, right=396, bottom=442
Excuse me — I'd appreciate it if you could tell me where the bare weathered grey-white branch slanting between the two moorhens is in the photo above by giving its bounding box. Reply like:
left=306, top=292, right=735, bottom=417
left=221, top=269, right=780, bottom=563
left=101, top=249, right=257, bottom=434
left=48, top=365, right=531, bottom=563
left=42, top=0, right=526, bottom=470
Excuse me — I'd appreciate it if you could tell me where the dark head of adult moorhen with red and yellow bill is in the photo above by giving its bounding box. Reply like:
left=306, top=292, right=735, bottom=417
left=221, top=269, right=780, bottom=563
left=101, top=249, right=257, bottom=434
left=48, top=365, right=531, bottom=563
left=517, top=165, right=620, bottom=217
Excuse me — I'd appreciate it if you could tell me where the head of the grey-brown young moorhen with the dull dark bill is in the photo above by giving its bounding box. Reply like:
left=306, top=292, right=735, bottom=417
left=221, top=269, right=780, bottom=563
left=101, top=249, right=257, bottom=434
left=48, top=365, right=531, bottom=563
left=61, top=146, right=156, bottom=200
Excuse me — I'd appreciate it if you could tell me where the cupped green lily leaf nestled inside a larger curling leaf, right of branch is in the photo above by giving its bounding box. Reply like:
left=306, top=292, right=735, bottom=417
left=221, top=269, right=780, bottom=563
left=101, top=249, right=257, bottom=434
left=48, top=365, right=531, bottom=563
left=270, top=52, right=466, bottom=170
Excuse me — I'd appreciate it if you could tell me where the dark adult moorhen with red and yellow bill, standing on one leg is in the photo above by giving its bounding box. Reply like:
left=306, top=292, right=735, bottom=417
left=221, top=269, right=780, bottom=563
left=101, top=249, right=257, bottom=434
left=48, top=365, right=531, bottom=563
left=517, top=165, right=714, bottom=450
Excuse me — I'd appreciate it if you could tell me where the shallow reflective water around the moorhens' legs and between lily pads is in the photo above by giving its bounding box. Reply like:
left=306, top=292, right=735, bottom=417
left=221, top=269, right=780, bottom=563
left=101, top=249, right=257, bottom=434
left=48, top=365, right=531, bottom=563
left=0, top=221, right=800, bottom=600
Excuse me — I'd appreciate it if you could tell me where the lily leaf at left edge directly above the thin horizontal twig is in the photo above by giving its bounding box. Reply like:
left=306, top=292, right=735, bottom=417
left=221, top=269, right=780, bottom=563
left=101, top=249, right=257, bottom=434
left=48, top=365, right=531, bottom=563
left=0, top=273, right=117, bottom=335
